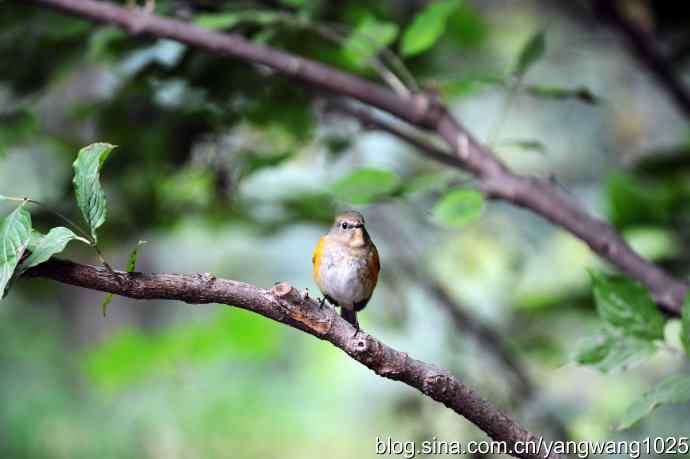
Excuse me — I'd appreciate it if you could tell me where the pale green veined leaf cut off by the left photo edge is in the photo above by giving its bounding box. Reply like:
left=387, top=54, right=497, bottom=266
left=0, top=203, right=31, bottom=299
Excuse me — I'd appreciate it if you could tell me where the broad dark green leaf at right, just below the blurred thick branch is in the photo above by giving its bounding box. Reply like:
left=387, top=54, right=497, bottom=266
left=590, top=271, right=665, bottom=341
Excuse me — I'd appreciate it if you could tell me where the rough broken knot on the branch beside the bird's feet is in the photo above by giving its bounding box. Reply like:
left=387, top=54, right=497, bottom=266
left=271, top=282, right=333, bottom=336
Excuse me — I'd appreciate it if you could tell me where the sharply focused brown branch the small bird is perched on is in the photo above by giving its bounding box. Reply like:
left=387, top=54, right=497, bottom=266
left=25, top=259, right=557, bottom=458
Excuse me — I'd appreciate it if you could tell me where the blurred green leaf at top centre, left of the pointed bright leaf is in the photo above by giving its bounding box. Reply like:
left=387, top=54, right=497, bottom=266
left=343, top=16, right=398, bottom=67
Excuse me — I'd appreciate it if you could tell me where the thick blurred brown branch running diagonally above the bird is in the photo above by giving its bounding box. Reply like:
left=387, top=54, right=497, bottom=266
left=25, top=0, right=687, bottom=315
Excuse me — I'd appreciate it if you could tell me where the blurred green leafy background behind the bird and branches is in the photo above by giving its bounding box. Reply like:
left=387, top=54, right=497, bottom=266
left=0, top=0, right=690, bottom=458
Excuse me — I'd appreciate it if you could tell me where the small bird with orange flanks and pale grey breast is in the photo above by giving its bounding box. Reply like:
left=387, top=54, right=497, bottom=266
left=311, top=211, right=381, bottom=331
